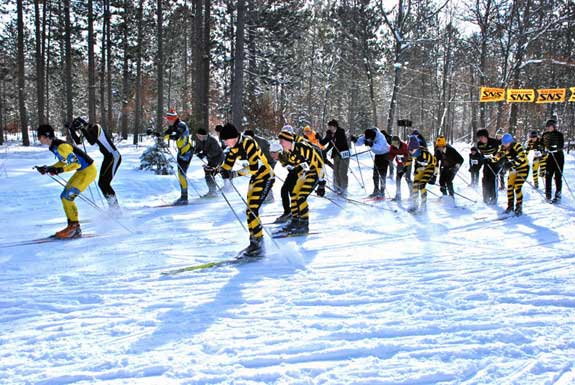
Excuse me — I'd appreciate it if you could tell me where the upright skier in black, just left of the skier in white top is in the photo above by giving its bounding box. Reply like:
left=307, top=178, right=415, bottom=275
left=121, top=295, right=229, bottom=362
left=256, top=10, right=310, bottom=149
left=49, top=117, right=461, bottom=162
left=320, top=119, right=350, bottom=196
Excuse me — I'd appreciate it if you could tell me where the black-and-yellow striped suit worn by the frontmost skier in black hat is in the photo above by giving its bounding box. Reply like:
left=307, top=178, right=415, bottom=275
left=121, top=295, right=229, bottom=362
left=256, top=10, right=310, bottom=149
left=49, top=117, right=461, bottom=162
left=222, top=135, right=275, bottom=238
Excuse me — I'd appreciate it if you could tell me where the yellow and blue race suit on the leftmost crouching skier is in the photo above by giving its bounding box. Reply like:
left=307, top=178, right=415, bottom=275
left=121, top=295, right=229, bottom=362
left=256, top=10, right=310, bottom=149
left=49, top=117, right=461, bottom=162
left=50, top=139, right=98, bottom=224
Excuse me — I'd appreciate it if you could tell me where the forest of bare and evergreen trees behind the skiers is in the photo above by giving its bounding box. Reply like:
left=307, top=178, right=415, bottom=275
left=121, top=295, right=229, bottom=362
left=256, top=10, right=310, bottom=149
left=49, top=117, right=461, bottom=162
left=0, top=0, right=575, bottom=145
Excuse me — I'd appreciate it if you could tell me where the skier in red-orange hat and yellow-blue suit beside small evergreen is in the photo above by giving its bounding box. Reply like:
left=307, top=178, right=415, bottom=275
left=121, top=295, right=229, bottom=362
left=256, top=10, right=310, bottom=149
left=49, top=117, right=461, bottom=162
left=164, top=108, right=194, bottom=206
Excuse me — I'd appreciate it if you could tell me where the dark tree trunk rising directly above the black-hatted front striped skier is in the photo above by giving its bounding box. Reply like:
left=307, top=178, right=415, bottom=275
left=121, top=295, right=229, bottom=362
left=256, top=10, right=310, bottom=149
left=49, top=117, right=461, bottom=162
left=232, top=0, right=245, bottom=130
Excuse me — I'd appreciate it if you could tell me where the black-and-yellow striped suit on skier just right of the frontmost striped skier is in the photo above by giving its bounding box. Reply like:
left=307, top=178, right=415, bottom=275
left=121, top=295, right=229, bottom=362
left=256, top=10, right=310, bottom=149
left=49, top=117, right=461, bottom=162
left=288, top=141, right=324, bottom=221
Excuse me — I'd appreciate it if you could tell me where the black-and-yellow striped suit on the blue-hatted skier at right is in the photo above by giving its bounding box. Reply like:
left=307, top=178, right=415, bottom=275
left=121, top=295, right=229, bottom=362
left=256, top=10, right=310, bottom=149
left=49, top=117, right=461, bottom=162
left=499, top=143, right=529, bottom=210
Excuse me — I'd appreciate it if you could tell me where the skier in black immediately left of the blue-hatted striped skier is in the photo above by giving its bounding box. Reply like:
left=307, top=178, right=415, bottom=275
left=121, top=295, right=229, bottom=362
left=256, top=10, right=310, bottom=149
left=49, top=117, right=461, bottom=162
left=476, top=128, right=501, bottom=205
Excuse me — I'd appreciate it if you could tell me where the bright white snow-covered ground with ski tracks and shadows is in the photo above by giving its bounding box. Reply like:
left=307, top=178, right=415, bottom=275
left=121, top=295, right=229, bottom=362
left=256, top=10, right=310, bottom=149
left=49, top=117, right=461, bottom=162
left=0, top=139, right=575, bottom=385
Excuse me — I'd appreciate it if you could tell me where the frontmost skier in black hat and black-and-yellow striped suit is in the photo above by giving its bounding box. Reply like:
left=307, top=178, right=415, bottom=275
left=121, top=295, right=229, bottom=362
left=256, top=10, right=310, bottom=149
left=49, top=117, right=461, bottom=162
left=220, top=123, right=275, bottom=257
